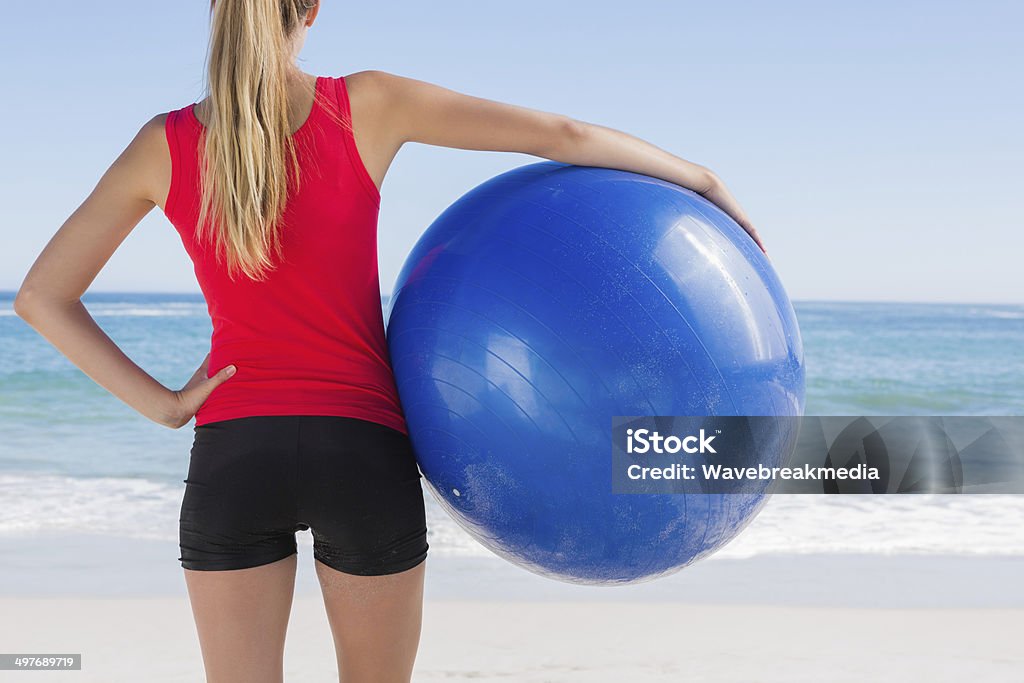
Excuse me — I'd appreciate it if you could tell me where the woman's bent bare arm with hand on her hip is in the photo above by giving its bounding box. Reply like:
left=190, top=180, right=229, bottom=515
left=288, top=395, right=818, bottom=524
left=14, top=115, right=229, bottom=429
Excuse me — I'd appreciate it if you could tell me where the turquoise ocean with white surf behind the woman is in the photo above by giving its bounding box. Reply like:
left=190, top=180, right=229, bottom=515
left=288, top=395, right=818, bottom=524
left=0, top=292, right=1024, bottom=558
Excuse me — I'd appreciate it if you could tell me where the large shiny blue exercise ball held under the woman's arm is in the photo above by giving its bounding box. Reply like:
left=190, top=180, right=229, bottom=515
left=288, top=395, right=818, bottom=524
left=387, top=162, right=804, bottom=585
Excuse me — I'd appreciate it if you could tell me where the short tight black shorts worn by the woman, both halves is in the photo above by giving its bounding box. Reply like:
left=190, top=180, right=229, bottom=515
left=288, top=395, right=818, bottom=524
left=178, top=415, right=427, bottom=575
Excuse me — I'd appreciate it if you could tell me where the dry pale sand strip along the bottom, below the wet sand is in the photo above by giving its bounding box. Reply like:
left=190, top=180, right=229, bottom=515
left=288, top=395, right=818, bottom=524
left=0, top=596, right=1024, bottom=683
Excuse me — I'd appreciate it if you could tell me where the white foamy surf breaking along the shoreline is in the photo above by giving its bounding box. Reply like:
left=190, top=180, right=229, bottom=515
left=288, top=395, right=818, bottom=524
left=0, top=474, right=1024, bottom=559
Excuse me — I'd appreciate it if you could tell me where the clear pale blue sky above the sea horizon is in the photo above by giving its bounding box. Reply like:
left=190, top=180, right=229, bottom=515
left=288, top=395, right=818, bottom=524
left=0, top=0, right=1024, bottom=302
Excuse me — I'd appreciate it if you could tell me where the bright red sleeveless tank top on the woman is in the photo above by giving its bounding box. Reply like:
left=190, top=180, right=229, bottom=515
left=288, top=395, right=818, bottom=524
left=165, top=76, right=407, bottom=433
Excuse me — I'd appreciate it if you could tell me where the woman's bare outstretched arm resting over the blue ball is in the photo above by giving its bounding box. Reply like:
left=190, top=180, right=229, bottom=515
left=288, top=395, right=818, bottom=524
left=364, top=71, right=764, bottom=250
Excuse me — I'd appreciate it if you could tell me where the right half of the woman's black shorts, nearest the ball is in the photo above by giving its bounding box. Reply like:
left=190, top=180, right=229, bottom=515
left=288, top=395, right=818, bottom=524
left=299, top=416, right=428, bottom=575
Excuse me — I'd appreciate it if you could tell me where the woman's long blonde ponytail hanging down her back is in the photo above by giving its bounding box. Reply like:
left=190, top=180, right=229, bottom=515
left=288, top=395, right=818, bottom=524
left=198, top=0, right=344, bottom=280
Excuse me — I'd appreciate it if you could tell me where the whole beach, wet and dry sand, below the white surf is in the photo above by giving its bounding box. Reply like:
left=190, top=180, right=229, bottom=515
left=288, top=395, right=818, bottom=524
left=0, top=538, right=1024, bottom=683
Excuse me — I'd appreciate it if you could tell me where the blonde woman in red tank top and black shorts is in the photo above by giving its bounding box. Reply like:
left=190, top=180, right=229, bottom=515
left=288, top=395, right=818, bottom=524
left=14, top=0, right=760, bottom=683
